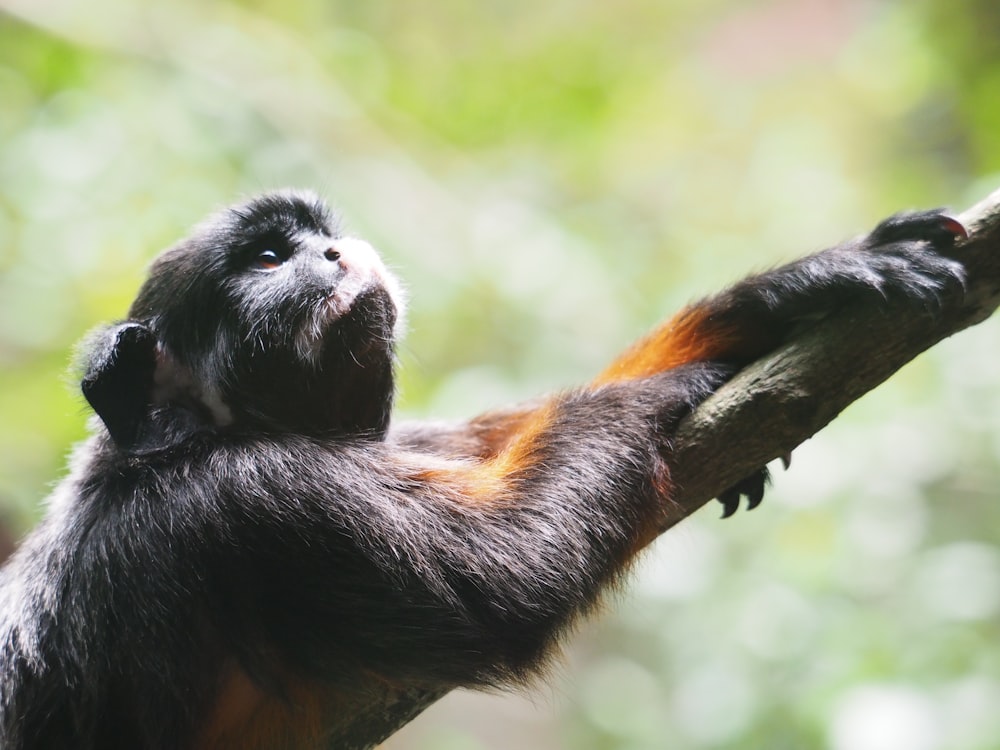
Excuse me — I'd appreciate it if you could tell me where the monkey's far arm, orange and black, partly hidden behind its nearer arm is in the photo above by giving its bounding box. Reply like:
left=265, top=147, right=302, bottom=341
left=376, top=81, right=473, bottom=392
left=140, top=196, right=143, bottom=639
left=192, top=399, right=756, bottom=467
left=389, top=211, right=966, bottom=478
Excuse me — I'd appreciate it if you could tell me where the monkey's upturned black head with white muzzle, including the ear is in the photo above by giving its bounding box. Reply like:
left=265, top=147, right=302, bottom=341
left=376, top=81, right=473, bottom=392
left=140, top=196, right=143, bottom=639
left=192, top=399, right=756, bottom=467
left=83, top=191, right=402, bottom=453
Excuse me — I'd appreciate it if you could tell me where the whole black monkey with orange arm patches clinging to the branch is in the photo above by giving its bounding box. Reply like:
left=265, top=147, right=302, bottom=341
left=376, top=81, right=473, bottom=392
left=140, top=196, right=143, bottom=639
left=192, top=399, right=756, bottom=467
left=0, top=192, right=964, bottom=750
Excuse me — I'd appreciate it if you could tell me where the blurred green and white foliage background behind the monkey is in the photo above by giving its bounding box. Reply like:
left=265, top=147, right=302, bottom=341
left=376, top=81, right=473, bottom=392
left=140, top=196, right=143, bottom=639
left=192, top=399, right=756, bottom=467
left=0, top=0, right=1000, bottom=750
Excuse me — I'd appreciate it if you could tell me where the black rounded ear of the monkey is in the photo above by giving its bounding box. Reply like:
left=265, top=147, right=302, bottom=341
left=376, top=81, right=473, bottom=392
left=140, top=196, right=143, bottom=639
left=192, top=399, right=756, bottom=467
left=80, top=323, right=156, bottom=452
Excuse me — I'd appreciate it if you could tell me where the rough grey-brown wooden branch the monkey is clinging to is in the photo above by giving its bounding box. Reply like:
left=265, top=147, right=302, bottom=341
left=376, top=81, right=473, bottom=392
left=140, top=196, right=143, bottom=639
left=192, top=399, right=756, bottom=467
left=329, top=190, right=1000, bottom=750
